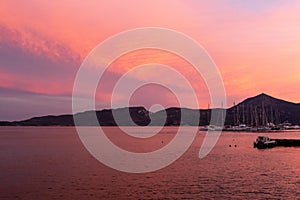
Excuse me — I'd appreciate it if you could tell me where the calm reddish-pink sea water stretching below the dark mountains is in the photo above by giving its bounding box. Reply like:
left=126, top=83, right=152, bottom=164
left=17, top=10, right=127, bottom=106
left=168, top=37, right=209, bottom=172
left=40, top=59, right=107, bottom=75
left=0, top=127, right=300, bottom=199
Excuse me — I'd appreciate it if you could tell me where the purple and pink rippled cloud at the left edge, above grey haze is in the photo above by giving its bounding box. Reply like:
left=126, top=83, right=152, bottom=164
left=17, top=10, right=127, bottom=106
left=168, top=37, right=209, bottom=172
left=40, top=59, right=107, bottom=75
left=0, top=23, right=80, bottom=94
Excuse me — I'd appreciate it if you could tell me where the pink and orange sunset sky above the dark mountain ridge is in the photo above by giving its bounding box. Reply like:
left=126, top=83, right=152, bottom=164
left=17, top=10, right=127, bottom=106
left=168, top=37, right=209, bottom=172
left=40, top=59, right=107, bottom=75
left=0, top=0, right=300, bottom=121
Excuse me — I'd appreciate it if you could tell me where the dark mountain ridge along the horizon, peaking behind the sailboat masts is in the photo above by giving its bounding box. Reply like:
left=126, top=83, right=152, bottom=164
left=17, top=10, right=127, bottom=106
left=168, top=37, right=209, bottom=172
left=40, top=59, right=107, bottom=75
left=0, top=93, right=300, bottom=126
